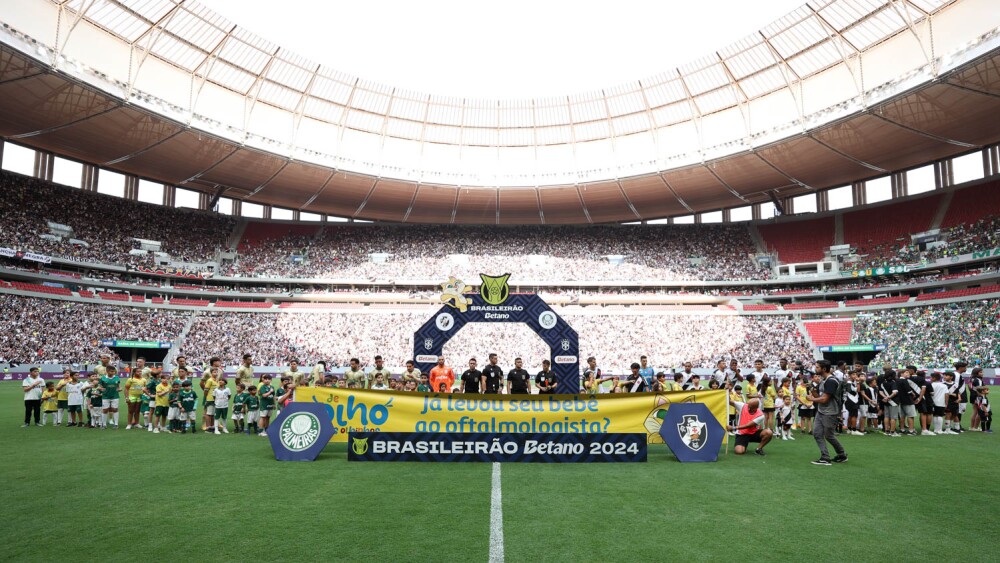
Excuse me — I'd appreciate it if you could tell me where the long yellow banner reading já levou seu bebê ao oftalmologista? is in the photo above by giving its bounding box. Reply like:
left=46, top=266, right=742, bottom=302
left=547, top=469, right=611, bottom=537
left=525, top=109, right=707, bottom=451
left=295, top=387, right=728, bottom=444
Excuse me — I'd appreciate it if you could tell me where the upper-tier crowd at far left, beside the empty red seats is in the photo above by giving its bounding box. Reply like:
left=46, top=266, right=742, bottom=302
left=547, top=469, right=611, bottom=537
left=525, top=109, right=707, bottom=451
left=0, top=172, right=235, bottom=264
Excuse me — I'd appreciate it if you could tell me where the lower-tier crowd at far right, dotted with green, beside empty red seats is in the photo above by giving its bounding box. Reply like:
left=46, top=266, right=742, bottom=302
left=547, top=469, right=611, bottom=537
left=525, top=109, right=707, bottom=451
left=851, top=299, right=1000, bottom=368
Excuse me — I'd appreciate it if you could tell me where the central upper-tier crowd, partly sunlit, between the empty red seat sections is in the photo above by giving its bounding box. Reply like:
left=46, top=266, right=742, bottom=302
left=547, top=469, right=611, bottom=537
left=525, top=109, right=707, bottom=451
left=229, top=225, right=771, bottom=282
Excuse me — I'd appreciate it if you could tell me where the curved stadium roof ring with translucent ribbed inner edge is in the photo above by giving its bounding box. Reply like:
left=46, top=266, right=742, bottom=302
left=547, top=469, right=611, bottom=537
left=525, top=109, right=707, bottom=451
left=0, top=0, right=1000, bottom=223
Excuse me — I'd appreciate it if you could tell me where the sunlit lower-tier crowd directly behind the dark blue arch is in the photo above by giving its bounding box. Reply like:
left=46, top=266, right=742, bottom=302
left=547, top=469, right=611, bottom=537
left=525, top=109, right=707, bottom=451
left=176, top=311, right=809, bottom=372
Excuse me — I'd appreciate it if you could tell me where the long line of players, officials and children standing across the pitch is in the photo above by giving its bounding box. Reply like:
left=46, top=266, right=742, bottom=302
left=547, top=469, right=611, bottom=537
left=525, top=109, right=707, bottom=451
left=19, top=354, right=990, bottom=437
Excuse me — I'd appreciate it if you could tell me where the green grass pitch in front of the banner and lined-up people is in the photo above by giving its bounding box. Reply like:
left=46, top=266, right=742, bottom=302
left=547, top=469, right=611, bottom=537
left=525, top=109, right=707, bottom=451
left=0, top=383, right=1000, bottom=562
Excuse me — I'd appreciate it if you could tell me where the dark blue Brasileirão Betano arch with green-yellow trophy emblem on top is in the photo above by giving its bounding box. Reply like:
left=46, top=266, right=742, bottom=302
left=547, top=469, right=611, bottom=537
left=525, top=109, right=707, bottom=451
left=413, top=273, right=580, bottom=394
